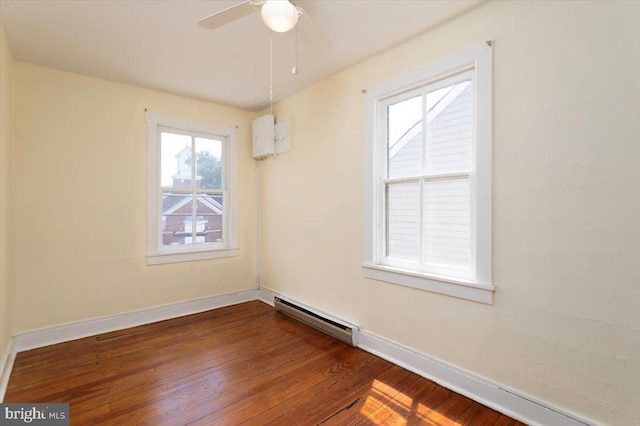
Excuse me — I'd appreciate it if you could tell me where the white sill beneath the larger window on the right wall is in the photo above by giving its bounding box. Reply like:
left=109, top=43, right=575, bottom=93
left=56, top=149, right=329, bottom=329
left=362, top=263, right=495, bottom=305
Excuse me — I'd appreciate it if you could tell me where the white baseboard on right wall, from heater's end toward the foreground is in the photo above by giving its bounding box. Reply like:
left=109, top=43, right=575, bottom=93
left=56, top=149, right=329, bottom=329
left=358, top=330, right=598, bottom=426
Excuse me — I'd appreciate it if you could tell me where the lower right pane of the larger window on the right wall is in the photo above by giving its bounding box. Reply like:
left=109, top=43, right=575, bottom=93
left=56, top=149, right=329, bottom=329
left=423, top=177, right=471, bottom=269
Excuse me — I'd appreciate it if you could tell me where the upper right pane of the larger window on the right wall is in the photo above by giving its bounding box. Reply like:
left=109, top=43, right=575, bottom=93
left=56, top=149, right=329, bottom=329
left=425, top=81, right=473, bottom=173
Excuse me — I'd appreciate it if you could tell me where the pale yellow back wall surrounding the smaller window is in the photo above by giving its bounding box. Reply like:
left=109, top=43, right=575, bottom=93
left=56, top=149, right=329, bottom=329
left=13, top=61, right=257, bottom=332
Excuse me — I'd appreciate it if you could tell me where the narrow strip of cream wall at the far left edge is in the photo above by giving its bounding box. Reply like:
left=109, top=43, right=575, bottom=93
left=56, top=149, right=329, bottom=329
left=0, top=27, right=13, bottom=360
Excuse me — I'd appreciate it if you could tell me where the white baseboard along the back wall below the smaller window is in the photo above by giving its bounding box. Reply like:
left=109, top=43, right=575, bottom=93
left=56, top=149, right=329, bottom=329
left=13, top=289, right=258, bottom=352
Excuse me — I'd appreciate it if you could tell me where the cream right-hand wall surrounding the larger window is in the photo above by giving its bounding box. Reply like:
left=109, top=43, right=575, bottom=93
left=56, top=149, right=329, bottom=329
left=261, top=1, right=640, bottom=425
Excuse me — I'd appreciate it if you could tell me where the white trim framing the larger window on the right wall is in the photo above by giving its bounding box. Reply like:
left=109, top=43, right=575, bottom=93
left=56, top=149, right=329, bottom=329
left=362, top=43, right=495, bottom=304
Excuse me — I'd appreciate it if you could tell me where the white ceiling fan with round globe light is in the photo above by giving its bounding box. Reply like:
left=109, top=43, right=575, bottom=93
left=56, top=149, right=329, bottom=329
left=198, top=0, right=331, bottom=52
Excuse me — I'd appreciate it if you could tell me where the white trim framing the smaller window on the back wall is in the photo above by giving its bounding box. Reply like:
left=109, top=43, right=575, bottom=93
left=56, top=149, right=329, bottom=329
left=145, top=112, right=239, bottom=265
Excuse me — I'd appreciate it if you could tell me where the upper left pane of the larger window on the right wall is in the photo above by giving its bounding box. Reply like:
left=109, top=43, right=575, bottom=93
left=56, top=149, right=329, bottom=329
left=387, top=96, right=422, bottom=178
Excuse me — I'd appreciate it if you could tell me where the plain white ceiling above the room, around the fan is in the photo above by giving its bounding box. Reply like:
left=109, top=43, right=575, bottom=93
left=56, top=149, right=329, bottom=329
left=0, top=0, right=484, bottom=111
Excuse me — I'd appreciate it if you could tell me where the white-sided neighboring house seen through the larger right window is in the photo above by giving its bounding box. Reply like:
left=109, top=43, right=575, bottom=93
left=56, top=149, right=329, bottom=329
left=387, top=81, right=473, bottom=269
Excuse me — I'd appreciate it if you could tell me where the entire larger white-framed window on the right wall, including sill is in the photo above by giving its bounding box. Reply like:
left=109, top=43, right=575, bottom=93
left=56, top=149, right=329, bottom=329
left=363, top=44, right=494, bottom=304
